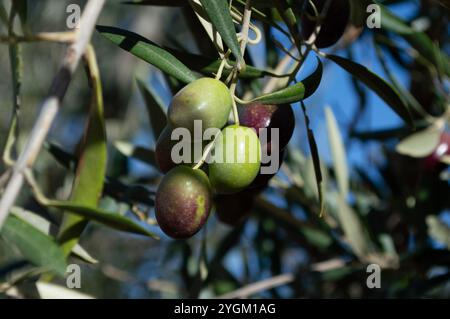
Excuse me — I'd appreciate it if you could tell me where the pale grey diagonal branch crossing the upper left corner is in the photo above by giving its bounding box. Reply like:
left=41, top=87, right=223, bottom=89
left=0, top=0, right=105, bottom=228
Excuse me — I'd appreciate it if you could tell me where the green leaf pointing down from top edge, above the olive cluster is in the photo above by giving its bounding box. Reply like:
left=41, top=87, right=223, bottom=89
left=200, top=0, right=244, bottom=64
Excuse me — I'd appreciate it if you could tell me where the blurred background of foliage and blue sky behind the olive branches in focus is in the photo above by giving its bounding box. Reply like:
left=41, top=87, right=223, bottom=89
left=0, top=0, right=450, bottom=298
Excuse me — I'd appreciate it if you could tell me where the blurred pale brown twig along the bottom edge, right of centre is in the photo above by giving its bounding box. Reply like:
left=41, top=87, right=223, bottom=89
left=218, top=274, right=295, bottom=299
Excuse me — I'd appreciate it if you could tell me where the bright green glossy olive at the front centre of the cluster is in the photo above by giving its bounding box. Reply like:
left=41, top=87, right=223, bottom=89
left=209, top=125, right=261, bottom=194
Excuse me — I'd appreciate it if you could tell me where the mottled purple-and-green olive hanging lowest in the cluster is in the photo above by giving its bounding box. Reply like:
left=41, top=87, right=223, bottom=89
left=155, top=165, right=212, bottom=239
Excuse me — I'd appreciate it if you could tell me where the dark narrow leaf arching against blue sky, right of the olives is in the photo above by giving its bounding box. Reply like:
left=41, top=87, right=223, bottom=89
left=327, top=55, right=413, bottom=126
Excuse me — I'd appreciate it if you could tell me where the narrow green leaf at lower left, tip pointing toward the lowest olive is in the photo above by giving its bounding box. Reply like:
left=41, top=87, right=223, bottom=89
left=49, top=200, right=159, bottom=240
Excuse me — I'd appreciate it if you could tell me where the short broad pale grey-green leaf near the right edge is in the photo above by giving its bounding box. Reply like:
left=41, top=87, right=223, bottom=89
left=395, top=125, right=442, bottom=158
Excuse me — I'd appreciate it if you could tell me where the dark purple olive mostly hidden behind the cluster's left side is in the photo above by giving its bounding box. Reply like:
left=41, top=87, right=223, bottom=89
left=155, top=126, right=203, bottom=173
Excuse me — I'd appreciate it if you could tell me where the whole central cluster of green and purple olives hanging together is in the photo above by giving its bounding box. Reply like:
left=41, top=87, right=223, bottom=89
left=155, top=78, right=295, bottom=239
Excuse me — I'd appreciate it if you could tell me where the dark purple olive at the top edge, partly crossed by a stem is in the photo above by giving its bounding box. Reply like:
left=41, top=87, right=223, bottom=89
left=301, top=0, right=350, bottom=48
